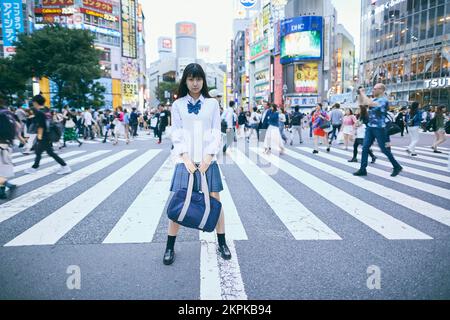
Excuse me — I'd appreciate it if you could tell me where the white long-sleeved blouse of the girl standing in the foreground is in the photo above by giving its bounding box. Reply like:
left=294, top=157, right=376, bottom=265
left=172, top=95, right=222, bottom=163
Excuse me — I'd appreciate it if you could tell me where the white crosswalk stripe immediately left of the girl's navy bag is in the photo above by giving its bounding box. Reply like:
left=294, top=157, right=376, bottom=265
left=103, top=157, right=174, bottom=243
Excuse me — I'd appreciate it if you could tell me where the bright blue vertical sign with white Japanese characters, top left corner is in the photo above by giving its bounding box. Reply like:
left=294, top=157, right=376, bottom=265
left=1, top=0, right=24, bottom=56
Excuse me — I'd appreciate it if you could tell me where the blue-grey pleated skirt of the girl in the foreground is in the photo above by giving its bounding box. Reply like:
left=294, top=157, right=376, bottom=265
left=170, top=161, right=223, bottom=192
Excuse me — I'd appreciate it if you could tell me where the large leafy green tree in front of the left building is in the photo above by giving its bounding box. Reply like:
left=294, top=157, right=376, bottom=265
left=13, top=25, right=101, bottom=108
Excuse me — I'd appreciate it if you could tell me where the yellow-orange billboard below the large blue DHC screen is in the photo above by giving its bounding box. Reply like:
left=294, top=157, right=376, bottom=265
left=294, top=62, right=319, bottom=94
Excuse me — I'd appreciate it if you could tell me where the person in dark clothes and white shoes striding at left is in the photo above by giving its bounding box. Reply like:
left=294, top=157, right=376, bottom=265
left=25, top=95, right=72, bottom=175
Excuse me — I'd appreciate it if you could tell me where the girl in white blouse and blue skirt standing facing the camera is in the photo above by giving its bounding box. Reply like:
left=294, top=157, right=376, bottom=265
left=163, top=63, right=231, bottom=265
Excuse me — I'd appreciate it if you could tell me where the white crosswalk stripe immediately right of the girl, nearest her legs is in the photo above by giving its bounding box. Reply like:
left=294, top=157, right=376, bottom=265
left=228, top=149, right=342, bottom=240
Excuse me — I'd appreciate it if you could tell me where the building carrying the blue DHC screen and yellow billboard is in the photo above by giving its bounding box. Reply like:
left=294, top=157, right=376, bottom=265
left=280, top=0, right=337, bottom=108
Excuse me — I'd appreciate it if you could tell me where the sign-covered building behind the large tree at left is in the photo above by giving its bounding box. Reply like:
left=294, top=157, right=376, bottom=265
left=2, top=0, right=147, bottom=109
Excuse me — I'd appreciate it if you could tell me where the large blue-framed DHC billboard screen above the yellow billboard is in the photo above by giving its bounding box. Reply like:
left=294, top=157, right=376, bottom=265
left=280, top=16, right=323, bottom=64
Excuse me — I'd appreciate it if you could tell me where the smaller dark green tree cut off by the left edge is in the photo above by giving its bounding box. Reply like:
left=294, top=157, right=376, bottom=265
left=0, top=58, right=27, bottom=106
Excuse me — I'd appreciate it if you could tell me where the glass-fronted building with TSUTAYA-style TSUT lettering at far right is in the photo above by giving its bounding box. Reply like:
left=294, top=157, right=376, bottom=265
left=359, top=0, right=450, bottom=105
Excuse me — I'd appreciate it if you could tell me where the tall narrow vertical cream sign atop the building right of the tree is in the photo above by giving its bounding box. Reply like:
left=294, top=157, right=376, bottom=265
left=120, top=0, right=137, bottom=59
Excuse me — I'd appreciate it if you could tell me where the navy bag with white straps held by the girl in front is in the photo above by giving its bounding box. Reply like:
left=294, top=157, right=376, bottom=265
left=167, top=173, right=222, bottom=232
